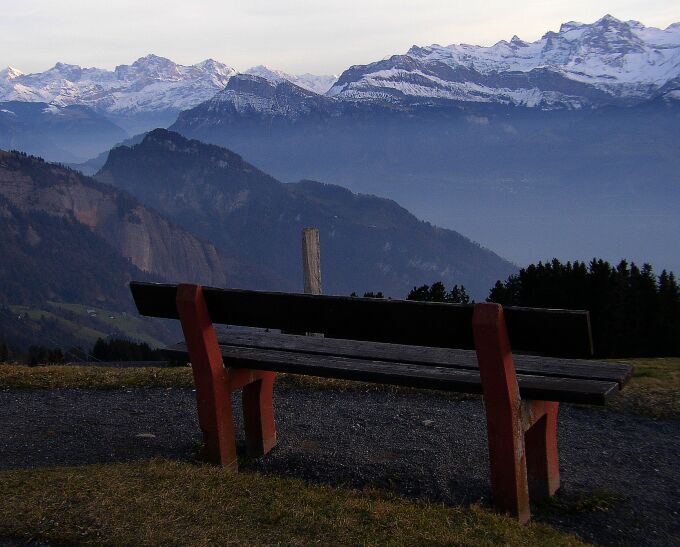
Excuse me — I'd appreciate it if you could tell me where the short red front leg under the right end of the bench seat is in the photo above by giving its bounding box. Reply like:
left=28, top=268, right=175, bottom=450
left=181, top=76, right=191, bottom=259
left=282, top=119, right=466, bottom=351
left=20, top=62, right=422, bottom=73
left=524, top=401, right=560, bottom=501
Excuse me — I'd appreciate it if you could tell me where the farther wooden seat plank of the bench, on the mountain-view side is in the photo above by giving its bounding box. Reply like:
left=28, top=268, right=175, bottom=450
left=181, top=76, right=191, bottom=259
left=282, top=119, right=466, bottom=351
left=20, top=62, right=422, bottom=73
left=201, top=329, right=633, bottom=387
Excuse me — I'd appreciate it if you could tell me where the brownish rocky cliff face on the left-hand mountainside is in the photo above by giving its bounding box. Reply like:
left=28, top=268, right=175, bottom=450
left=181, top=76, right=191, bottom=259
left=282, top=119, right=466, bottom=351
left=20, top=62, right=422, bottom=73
left=0, top=152, right=226, bottom=286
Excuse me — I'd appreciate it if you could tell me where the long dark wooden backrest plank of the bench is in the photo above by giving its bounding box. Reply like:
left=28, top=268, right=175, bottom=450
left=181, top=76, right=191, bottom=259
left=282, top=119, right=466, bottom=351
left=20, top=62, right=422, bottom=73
left=130, top=282, right=593, bottom=357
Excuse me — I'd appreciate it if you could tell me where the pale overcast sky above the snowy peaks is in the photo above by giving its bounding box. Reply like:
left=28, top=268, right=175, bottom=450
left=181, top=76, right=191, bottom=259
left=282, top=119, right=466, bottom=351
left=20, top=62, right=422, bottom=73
left=0, top=0, right=680, bottom=74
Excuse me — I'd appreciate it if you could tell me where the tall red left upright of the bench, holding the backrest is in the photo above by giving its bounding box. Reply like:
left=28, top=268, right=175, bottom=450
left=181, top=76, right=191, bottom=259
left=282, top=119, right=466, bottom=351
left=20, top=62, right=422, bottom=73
left=176, top=284, right=238, bottom=471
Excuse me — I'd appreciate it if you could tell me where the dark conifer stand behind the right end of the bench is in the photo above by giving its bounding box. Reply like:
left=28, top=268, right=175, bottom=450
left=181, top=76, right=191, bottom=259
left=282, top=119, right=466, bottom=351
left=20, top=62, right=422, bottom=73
left=487, top=259, right=680, bottom=357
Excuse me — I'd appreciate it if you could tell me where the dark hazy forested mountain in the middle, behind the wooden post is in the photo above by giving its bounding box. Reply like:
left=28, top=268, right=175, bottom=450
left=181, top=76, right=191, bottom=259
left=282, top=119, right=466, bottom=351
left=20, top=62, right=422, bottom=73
left=97, top=130, right=514, bottom=297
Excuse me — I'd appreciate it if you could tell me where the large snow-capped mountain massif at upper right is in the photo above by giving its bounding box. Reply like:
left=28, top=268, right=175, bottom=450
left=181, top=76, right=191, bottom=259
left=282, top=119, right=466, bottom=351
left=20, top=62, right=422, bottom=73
left=328, top=15, right=680, bottom=108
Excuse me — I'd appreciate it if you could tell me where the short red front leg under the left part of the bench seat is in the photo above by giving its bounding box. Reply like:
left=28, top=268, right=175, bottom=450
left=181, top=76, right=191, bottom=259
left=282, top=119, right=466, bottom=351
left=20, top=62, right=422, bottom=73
left=243, top=372, right=276, bottom=457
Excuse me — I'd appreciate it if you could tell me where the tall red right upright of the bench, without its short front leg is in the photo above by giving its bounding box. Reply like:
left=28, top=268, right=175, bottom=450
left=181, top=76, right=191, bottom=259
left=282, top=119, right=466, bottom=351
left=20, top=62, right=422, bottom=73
left=472, top=303, right=531, bottom=523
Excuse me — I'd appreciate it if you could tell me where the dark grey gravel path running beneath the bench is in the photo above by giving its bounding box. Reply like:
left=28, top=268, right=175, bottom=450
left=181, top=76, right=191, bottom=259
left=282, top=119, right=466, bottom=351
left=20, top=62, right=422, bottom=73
left=0, top=389, right=680, bottom=545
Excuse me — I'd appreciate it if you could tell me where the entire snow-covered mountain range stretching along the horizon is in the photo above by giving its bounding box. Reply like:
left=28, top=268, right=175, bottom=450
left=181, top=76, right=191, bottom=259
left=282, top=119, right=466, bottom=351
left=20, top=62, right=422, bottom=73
left=0, top=15, right=680, bottom=132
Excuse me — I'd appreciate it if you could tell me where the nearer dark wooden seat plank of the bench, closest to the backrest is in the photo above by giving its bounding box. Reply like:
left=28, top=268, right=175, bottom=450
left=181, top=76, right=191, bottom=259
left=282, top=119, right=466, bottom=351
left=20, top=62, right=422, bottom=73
left=163, top=346, right=618, bottom=405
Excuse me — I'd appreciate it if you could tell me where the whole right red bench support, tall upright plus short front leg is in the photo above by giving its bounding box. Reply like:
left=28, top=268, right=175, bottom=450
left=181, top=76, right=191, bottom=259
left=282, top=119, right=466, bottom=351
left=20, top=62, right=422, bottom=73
left=472, top=303, right=560, bottom=522
